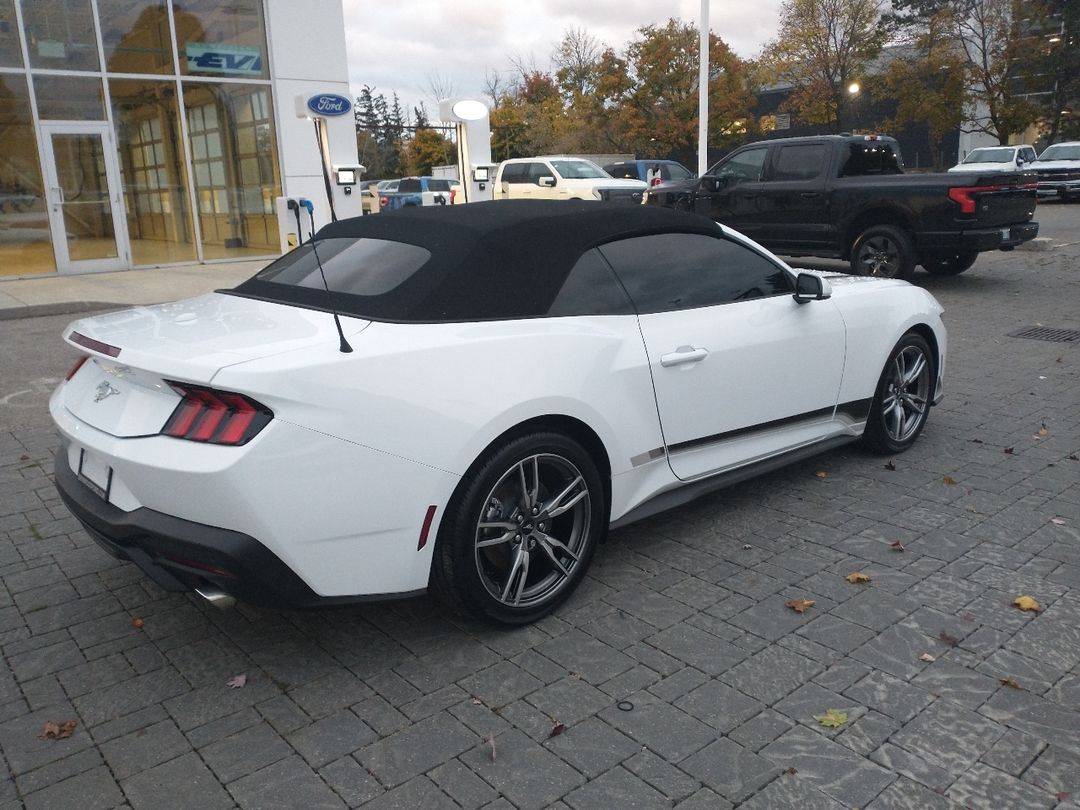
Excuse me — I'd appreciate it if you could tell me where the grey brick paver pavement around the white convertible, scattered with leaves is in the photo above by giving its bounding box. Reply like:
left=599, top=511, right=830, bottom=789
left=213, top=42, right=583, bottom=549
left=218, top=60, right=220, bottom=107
left=0, top=206, right=1080, bottom=810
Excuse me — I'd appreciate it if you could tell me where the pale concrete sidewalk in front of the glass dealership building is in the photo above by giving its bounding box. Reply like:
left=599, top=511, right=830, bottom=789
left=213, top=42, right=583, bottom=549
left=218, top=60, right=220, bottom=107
left=0, top=259, right=269, bottom=321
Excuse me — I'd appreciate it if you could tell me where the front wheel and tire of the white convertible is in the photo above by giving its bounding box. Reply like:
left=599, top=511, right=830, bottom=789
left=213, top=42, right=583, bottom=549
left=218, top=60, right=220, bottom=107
left=863, top=332, right=936, bottom=455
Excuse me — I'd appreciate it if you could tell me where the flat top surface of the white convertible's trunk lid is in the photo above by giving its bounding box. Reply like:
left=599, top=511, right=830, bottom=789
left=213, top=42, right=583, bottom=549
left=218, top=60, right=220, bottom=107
left=64, top=293, right=370, bottom=383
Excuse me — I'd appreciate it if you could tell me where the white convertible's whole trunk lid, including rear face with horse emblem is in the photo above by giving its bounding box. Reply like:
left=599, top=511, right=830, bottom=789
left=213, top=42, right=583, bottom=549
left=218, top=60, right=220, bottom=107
left=58, top=293, right=369, bottom=437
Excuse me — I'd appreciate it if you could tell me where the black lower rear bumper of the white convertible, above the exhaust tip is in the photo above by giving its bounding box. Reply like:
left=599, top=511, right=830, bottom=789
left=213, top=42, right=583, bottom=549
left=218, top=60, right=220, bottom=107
left=54, top=448, right=421, bottom=607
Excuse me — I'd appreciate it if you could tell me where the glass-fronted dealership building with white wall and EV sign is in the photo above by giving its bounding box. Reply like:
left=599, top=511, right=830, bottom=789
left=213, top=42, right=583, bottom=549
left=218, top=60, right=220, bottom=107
left=0, top=0, right=361, bottom=276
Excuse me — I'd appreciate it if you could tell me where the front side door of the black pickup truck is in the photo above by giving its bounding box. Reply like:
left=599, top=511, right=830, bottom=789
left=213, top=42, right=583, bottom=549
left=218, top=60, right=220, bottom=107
left=696, top=144, right=769, bottom=239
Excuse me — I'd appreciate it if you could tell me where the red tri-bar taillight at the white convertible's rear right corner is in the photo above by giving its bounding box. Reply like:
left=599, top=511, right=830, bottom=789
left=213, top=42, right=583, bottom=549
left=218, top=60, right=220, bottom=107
left=161, top=380, right=273, bottom=446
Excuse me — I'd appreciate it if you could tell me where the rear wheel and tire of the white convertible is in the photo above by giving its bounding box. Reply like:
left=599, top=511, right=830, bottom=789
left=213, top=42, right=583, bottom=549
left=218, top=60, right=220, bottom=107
left=431, top=432, right=608, bottom=625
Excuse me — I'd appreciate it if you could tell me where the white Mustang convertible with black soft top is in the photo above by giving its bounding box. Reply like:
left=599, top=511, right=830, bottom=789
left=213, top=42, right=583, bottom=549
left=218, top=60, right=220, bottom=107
left=50, top=201, right=946, bottom=624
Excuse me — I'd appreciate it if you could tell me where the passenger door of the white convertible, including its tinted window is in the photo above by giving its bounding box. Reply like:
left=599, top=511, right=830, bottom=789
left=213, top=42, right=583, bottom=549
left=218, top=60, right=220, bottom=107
left=600, top=233, right=846, bottom=480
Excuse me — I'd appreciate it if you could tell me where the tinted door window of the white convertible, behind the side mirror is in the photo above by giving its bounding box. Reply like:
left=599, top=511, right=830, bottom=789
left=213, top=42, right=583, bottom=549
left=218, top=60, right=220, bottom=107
left=599, top=233, right=793, bottom=314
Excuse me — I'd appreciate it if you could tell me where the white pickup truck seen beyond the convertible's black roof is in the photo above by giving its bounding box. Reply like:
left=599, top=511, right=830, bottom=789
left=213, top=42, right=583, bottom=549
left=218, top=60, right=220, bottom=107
left=491, top=156, right=648, bottom=204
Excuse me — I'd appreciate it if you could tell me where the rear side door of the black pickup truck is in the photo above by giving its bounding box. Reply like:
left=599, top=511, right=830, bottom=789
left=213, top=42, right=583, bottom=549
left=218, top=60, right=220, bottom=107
left=747, top=141, right=835, bottom=253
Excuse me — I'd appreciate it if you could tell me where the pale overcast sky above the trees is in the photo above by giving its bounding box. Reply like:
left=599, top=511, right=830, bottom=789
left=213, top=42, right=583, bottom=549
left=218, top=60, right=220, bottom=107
left=345, top=0, right=781, bottom=118
